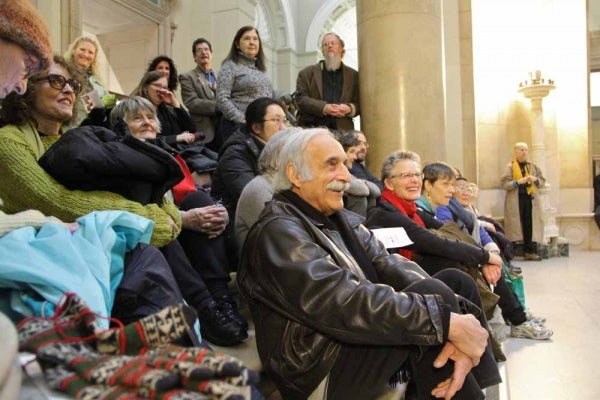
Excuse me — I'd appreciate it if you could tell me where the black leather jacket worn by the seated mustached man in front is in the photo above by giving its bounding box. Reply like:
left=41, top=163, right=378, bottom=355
left=238, top=195, right=448, bottom=399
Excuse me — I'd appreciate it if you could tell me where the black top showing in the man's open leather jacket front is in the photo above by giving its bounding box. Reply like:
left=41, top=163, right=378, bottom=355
left=273, top=190, right=379, bottom=283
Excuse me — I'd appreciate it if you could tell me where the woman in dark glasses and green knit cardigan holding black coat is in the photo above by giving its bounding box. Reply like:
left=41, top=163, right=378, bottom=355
left=0, top=56, right=182, bottom=247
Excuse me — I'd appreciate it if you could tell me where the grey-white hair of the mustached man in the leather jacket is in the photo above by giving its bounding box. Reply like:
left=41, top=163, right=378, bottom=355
left=273, top=128, right=334, bottom=192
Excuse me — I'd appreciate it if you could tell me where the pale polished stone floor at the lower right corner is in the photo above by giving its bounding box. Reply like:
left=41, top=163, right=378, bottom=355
left=504, top=252, right=600, bottom=400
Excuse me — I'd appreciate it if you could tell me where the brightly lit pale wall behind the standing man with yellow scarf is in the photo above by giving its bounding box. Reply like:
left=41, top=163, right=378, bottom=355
left=472, top=0, right=591, bottom=222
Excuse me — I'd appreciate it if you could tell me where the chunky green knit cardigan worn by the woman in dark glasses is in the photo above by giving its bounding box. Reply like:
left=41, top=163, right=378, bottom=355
left=0, top=124, right=181, bottom=247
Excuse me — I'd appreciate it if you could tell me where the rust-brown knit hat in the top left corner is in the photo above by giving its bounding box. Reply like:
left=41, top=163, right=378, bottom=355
left=0, top=0, right=52, bottom=72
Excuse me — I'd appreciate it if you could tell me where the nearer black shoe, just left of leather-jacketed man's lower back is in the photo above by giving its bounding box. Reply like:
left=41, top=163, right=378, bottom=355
left=198, top=301, right=248, bottom=346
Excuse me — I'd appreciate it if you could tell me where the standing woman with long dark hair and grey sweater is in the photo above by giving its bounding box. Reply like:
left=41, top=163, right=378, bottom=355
left=217, top=26, right=273, bottom=142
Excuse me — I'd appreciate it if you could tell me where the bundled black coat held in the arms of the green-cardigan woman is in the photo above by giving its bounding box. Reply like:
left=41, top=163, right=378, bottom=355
left=38, top=126, right=183, bottom=204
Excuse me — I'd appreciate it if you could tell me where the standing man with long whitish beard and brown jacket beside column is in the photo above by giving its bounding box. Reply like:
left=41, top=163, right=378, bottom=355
left=296, top=33, right=360, bottom=130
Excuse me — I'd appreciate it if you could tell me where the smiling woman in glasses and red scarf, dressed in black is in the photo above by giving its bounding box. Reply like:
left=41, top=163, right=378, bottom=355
left=365, top=151, right=497, bottom=275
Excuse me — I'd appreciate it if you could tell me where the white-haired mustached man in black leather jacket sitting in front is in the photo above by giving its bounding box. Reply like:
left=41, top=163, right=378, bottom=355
left=238, top=129, right=500, bottom=399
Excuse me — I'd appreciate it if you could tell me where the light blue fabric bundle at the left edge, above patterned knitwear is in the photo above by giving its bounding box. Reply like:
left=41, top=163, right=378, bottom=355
left=0, top=211, right=154, bottom=328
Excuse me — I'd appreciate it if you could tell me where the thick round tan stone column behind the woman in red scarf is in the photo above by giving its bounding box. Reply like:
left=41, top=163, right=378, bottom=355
left=356, top=0, right=446, bottom=171
